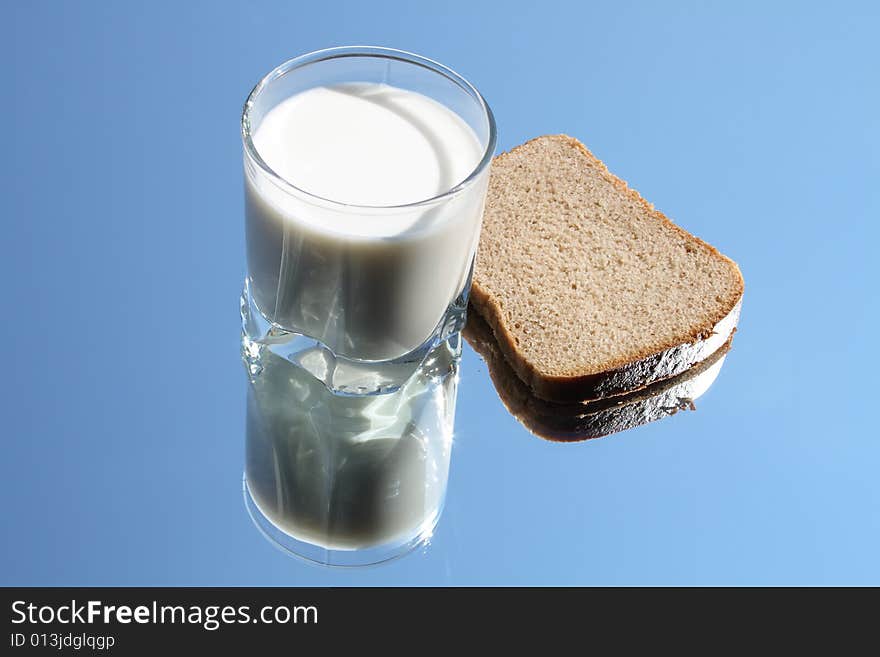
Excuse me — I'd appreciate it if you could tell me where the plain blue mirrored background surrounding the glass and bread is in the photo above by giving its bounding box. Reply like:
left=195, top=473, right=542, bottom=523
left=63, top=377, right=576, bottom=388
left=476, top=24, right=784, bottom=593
left=0, top=0, right=880, bottom=585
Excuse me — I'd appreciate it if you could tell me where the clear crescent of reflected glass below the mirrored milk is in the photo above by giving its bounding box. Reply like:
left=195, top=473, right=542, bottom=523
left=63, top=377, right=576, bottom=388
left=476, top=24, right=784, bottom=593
left=241, top=476, right=443, bottom=568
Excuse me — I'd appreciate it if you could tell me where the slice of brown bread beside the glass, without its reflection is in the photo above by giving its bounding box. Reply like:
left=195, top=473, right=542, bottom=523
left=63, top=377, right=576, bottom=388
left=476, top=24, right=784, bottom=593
left=470, top=135, right=743, bottom=401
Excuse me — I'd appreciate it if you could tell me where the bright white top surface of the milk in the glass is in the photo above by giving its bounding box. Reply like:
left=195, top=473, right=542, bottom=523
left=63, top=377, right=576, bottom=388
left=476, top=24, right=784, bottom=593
left=254, top=83, right=482, bottom=209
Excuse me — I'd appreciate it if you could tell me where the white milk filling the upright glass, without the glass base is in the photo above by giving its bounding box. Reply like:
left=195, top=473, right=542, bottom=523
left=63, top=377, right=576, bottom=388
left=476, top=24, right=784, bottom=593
left=245, top=83, right=488, bottom=360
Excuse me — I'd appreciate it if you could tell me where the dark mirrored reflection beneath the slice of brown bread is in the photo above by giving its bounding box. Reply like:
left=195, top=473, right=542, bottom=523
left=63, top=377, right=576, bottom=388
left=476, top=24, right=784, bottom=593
left=464, top=312, right=731, bottom=442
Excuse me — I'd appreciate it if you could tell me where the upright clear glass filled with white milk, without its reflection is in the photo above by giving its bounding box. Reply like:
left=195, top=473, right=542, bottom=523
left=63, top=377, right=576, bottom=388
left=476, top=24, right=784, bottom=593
left=241, top=47, right=496, bottom=395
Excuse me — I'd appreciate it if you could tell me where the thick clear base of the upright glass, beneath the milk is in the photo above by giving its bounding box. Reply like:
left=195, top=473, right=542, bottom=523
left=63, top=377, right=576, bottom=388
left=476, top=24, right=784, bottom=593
left=241, top=277, right=470, bottom=396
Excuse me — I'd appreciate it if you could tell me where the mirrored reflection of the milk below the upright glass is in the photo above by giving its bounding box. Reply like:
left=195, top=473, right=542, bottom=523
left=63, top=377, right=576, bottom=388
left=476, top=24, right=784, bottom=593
left=245, top=337, right=461, bottom=550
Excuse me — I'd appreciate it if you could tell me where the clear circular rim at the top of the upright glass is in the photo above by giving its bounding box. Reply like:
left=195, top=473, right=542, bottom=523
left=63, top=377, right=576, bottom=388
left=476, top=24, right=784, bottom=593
left=241, top=46, right=498, bottom=210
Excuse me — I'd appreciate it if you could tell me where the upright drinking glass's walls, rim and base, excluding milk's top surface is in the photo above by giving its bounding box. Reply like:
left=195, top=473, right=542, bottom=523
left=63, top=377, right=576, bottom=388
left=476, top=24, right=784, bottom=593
left=241, top=46, right=496, bottom=394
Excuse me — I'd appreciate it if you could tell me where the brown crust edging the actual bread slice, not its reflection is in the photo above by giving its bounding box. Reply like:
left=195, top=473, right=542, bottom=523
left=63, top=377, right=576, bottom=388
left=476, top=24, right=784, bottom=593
left=470, top=135, right=745, bottom=401
